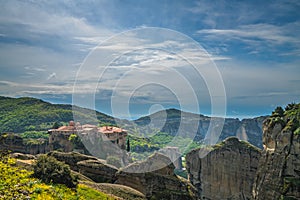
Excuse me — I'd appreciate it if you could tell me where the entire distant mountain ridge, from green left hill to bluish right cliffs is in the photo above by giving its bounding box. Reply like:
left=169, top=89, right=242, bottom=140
left=0, top=96, right=266, bottom=148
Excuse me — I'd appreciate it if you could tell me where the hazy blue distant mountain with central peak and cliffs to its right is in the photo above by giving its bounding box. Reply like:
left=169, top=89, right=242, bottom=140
left=135, top=109, right=267, bottom=148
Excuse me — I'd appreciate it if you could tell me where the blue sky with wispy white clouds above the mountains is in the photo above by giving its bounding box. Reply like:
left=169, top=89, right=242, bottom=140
left=0, top=0, right=300, bottom=119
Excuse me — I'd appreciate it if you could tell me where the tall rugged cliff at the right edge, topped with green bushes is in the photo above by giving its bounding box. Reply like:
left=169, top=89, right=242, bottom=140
left=253, top=104, right=300, bottom=200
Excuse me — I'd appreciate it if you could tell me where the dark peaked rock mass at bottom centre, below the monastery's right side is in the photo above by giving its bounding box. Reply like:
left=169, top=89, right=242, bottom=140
left=116, top=153, right=196, bottom=200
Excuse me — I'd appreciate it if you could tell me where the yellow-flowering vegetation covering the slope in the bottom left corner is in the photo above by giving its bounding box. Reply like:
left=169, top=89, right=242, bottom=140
left=0, top=151, right=115, bottom=200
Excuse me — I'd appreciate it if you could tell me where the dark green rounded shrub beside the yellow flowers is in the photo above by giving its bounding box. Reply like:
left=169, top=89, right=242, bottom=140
left=33, top=155, right=77, bottom=188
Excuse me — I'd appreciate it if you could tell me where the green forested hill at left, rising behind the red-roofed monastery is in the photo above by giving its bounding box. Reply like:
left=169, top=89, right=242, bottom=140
left=0, top=96, right=115, bottom=133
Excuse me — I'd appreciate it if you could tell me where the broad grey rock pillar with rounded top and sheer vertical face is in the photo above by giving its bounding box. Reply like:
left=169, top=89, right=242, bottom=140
left=186, top=137, right=260, bottom=199
